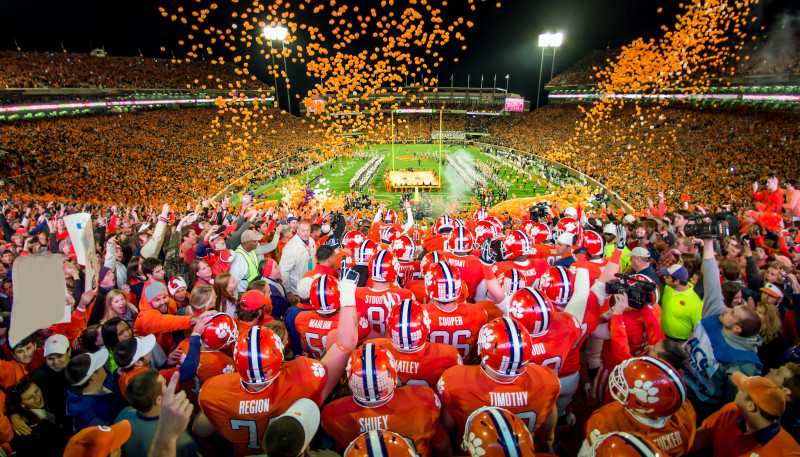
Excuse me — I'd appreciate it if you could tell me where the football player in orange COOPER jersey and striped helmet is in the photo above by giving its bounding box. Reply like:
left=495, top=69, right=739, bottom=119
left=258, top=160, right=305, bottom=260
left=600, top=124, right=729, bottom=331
left=425, top=262, right=488, bottom=360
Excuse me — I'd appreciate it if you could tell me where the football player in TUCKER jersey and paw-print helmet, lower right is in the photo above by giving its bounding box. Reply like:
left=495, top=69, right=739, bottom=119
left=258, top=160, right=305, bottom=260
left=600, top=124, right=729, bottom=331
left=578, top=357, right=697, bottom=457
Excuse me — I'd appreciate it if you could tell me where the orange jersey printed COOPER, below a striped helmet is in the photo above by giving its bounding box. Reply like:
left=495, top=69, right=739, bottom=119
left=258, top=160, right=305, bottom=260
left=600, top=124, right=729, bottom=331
left=423, top=303, right=488, bottom=360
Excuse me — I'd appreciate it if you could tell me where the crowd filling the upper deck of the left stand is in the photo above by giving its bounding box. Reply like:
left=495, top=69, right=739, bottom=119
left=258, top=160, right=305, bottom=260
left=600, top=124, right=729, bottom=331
left=0, top=51, right=263, bottom=89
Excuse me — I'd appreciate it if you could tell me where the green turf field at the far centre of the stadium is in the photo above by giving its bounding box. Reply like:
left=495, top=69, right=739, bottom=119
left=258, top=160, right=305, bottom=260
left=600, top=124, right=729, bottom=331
left=232, top=144, right=545, bottom=205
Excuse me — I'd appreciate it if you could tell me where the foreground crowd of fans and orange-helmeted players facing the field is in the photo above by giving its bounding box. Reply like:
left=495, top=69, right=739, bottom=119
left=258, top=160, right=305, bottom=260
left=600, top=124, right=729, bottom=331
left=0, top=172, right=800, bottom=457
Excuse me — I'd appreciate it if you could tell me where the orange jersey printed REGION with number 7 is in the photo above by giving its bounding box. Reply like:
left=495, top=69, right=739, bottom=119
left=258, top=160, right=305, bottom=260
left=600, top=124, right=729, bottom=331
left=200, top=357, right=328, bottom=456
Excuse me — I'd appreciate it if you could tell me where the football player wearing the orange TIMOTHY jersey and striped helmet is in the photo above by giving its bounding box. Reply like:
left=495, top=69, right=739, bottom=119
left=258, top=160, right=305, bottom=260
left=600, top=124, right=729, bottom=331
left=436, top=317, right=561, bottom=451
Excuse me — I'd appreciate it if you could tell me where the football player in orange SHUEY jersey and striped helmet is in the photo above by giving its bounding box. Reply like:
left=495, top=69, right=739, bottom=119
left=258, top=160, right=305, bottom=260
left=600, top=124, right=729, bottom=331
left=322, top=343, right=451, bottom=456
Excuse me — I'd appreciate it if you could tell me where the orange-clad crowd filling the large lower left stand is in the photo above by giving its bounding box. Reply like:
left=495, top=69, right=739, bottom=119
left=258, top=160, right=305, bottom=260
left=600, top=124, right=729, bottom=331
left=0, top=108, right=319, bottom=204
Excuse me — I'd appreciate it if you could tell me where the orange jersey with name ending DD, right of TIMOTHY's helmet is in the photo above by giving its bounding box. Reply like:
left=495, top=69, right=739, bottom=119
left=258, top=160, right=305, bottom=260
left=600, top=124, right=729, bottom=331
left=531, top=311, right=581, bottom=376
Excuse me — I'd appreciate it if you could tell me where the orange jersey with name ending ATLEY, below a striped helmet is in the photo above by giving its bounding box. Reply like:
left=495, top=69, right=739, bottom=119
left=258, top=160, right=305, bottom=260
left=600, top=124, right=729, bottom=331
left=365, top=338, right=464, bottom=388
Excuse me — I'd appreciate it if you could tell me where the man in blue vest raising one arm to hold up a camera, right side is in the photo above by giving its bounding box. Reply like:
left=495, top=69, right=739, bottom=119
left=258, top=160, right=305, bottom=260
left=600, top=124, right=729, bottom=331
left=681, top=238, right=762, bottom=420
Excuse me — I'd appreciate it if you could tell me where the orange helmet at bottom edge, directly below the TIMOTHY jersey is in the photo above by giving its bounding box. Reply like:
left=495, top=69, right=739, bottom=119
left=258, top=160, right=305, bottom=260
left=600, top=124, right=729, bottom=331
left=461, top=406, right=534, bottom=457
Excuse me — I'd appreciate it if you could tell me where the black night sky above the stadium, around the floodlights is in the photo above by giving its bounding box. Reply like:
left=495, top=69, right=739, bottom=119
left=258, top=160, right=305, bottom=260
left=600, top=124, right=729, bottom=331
left=0, top=0, right=800, bottom=113
